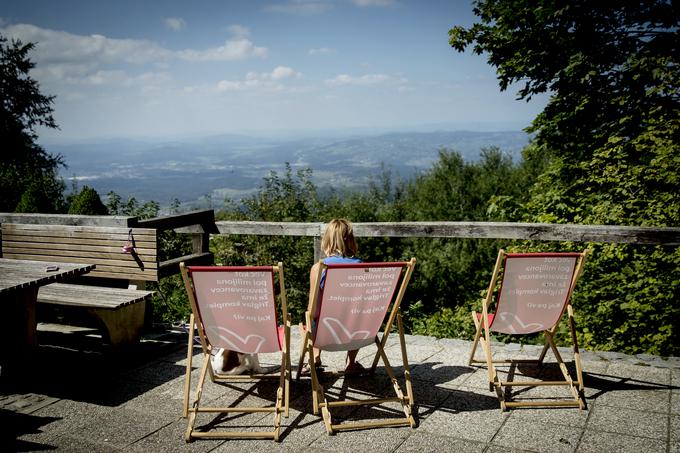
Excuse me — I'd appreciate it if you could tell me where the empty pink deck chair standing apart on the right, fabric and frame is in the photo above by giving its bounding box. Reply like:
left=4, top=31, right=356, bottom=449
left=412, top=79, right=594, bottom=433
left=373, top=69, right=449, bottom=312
left=468, top=250, right=587, bottom=410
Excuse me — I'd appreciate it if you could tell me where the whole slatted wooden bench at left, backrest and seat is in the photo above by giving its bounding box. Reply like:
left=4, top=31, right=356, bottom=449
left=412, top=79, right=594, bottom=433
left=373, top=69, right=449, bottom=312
left=2, top=223, right=159, bottom=347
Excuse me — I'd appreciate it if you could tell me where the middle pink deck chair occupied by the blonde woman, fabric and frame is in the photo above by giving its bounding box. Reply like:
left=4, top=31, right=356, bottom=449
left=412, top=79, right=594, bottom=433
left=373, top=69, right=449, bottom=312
left=297, top=258, right=416, bottom=434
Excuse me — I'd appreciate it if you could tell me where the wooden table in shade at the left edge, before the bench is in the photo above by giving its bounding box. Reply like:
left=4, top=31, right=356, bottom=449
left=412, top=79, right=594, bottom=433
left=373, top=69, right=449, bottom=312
left=0, top=258, right=95, bottom=358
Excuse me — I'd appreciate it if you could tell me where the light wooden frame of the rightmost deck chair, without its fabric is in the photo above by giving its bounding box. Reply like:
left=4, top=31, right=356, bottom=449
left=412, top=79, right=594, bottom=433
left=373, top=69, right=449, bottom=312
left=468, top=250, right=588, bottom=411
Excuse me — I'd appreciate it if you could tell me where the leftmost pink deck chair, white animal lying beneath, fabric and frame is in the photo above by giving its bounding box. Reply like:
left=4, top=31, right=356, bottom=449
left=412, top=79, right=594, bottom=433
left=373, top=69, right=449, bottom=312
left=180, top=263, right=291, bottom=442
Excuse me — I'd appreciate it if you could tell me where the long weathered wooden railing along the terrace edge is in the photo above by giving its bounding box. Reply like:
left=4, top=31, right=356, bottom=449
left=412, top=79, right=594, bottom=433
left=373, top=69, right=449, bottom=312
left=0, top=209, right=680, bottom=266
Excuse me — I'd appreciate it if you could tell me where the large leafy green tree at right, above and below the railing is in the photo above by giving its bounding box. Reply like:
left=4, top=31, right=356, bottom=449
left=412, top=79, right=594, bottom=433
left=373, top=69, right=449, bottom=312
left=450, top=0, right=680, bottom=354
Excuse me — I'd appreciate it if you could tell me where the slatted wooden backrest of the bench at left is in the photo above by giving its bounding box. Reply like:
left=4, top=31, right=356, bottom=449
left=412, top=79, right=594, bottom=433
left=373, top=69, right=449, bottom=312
left=2, top=223, right=158, bottom=281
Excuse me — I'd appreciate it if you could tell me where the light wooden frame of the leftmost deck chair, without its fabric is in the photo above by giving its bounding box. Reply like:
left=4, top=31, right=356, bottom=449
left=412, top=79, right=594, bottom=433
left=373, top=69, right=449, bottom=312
left=180, top=263, right=291, bottom=442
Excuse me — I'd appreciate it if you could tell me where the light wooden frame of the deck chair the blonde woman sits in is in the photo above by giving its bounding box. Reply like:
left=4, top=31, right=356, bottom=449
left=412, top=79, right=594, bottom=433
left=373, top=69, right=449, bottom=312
left=297, top=258, right=416, bottom=435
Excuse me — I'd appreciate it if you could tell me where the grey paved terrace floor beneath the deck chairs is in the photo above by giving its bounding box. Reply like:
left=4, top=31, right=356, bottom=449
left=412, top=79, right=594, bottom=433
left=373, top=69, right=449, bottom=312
left=0, top=329, right=680, bottom=453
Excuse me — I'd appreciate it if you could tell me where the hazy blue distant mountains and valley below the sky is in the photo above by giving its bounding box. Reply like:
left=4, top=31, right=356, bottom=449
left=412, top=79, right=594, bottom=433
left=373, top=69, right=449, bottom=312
left=44, top=131, right=529, bottom=208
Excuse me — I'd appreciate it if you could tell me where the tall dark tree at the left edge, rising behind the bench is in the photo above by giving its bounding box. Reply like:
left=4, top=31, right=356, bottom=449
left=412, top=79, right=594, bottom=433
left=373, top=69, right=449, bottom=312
left=0, top=35, right=64, bottom=213
